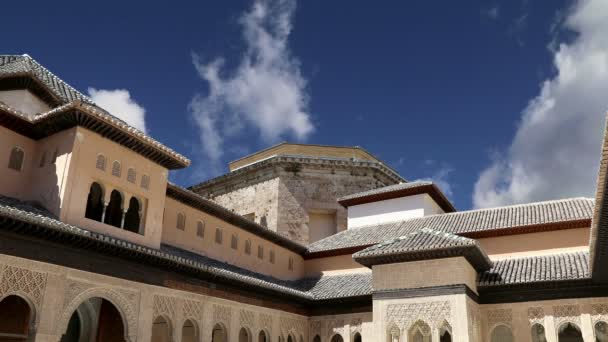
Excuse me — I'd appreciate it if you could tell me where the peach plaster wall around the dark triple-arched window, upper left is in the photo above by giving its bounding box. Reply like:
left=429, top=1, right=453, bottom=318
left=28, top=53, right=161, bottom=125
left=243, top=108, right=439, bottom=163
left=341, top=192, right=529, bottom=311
left=60, top=127, right=167, bottom=248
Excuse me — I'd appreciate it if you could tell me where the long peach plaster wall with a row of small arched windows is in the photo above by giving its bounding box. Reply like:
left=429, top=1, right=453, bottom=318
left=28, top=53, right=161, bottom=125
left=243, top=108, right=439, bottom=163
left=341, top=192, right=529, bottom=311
left=162, top=198, right=304, bottom=280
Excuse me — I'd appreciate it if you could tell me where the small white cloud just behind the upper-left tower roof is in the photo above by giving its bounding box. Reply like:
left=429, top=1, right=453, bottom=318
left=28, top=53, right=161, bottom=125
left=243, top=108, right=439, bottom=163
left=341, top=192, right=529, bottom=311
left=89, top=88, right=147, bottom=133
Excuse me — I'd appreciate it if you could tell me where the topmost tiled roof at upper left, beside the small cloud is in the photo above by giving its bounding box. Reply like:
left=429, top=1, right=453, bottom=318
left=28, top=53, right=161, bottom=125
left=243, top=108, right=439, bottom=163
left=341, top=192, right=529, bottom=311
left=0, top=55, right=92, bottom=104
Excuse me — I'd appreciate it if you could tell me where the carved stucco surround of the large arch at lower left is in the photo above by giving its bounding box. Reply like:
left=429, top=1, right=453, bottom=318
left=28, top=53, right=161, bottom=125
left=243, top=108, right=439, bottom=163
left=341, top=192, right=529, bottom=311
left=57, top=280, right=139, bottom=342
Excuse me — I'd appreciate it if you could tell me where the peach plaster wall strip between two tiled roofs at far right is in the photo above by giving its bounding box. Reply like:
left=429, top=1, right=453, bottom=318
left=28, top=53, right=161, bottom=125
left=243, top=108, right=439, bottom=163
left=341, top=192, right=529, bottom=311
left=478, top=228, right=590, bottom=260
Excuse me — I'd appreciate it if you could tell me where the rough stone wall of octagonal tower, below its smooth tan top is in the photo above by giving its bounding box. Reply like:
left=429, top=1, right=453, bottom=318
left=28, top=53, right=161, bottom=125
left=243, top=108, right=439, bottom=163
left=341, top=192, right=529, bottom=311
left=193, top=158, right=398, bottom=244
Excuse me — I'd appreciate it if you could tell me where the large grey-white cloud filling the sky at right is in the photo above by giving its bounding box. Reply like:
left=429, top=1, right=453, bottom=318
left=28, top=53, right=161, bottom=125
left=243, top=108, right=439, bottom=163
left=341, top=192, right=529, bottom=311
left=473, top=0, right=608, bottom=207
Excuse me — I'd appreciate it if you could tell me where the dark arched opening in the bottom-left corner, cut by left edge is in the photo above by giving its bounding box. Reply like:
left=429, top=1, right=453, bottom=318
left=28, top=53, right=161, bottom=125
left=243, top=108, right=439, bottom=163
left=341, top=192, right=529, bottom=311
left=0, top=295, right=32, bottom=342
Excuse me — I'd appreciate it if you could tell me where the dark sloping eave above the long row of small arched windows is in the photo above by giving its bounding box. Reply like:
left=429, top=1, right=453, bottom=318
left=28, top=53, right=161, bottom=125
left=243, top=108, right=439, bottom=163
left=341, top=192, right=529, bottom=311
left=167, top=182, right=306, bottom=254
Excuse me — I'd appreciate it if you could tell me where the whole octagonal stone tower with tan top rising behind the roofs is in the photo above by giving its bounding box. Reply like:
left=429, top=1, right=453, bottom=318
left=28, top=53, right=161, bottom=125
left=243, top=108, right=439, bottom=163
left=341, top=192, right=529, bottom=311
left=191, top=143, right=405, bottom=244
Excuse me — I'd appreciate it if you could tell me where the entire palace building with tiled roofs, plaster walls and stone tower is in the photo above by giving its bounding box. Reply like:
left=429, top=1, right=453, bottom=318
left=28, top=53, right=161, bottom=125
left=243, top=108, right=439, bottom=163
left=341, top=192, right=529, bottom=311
left=0, top=55, right=608, bottom=342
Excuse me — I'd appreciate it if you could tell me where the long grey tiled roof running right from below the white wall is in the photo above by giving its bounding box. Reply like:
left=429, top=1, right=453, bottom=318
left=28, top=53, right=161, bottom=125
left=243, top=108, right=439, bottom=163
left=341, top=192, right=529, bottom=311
left=308, top=198, right=594, bottom=254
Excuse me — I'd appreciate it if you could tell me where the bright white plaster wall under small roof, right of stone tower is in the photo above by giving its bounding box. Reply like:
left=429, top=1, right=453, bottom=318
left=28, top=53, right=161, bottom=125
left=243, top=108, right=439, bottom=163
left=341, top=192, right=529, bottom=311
left=348, top=194, right=443, bottom=229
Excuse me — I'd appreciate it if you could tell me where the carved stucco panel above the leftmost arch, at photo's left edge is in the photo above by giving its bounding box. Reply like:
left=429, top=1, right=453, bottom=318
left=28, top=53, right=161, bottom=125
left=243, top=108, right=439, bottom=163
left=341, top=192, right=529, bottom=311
left=0, top=265, right=47, bottom=317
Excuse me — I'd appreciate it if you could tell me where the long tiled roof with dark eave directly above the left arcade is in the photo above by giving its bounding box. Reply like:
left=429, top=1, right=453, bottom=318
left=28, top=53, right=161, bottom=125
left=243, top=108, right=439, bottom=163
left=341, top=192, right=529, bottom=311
left=0, top=195, right=371, bottom=300
